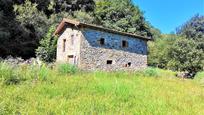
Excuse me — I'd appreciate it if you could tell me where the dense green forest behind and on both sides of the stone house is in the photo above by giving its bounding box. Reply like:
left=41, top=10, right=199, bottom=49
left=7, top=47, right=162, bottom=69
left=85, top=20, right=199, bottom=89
left=0, top=0, right=204, bottom=75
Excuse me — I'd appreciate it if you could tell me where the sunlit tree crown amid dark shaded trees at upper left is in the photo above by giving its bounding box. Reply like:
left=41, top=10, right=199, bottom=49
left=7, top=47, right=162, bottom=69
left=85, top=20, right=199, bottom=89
left=14, top=0, right=49, bottom=40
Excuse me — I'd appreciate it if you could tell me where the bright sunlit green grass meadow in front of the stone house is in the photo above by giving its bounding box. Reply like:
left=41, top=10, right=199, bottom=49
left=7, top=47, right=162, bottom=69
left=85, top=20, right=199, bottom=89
left=0, top=64, right=204, bottom=115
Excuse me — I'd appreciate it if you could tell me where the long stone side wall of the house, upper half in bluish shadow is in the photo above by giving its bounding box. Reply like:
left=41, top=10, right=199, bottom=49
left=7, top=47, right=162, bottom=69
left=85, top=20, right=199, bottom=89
left=80, top=28, right=147, bottom=70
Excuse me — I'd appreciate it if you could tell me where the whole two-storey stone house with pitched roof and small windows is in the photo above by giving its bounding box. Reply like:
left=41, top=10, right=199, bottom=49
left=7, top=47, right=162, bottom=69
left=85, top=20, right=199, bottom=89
left=55, top=19, right=150, bottom=71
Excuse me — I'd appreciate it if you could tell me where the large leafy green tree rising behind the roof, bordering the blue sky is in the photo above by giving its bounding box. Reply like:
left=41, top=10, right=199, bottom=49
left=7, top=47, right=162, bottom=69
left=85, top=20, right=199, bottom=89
left=94, top=0, right=152, bottom=37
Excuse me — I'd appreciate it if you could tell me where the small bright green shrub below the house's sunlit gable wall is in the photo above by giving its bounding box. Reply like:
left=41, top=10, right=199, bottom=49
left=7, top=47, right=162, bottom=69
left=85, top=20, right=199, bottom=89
left=57, top=64, right=77, bottom=74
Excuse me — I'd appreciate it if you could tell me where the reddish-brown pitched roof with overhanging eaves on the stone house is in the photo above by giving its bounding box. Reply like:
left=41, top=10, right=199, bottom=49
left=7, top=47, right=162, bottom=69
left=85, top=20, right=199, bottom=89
left=54, top=18, right=151, bottom=40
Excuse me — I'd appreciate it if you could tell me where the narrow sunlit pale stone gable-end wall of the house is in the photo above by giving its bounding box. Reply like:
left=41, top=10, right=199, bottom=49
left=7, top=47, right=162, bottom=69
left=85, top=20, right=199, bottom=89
left=57, top=27, right=81, bottom=65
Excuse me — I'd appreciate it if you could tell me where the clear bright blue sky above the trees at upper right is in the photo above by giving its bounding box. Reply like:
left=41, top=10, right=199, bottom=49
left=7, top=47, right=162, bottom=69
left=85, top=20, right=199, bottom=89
left=133, top=0, right=204, bottom=33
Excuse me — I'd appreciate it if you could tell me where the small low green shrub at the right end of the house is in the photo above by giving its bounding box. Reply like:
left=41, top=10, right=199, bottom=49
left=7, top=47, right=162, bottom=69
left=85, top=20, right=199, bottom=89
left=144, top=67, right=159, bottom=77
